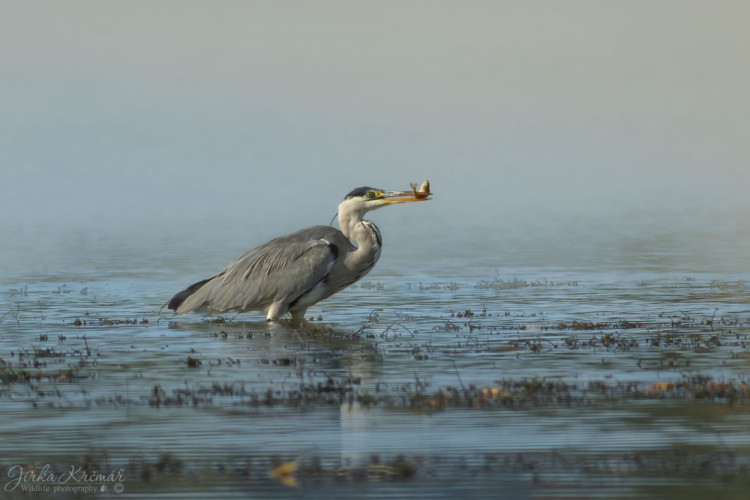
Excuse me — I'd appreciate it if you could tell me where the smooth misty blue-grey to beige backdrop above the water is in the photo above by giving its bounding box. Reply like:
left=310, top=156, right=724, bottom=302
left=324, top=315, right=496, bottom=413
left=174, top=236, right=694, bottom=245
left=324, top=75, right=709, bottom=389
left=0, top=0, right=750, bottom=269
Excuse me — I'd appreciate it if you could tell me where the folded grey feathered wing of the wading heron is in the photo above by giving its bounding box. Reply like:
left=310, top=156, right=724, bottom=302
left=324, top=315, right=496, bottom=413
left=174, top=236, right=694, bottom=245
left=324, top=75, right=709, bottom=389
left=176, top=226, right=343, bottom=314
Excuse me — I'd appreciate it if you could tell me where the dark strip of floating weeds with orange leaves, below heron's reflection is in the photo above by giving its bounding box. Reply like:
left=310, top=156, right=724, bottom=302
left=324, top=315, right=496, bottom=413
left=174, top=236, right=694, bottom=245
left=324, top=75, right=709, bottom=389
left=35, top=372, right=750, bottom=411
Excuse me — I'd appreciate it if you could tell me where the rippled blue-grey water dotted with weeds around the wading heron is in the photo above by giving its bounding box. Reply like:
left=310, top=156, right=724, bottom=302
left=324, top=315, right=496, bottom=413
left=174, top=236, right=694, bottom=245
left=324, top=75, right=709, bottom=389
left=0, top=209, right=750, bottom=498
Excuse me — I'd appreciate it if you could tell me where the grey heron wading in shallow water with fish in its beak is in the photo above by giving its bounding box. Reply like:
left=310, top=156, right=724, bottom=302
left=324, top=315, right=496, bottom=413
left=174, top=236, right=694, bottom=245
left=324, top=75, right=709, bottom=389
left=167, top=187, right=429, bottom=322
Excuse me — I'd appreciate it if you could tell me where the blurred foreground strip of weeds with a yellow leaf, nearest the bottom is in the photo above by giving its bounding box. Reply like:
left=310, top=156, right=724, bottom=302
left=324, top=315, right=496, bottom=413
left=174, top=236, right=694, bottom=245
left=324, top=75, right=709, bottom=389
left=0, top=446, right=750, bottom=490
